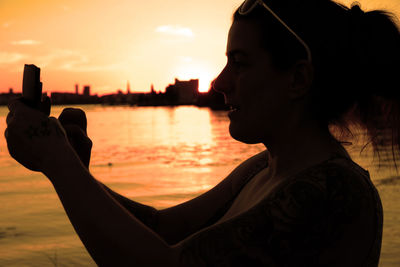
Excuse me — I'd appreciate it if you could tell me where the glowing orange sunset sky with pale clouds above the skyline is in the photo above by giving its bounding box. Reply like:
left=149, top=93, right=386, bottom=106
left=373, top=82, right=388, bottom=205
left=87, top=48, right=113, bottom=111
left=0, top=0, right=400, bottom=95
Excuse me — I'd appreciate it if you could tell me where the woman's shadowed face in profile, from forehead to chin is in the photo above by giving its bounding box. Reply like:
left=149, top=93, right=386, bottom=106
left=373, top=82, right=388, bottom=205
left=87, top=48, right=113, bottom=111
left=214, top=20, right=290, bottom=144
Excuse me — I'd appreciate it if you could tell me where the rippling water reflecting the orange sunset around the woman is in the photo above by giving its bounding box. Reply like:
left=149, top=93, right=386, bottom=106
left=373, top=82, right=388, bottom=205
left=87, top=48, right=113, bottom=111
left=0, top=105, right=400, bottom=266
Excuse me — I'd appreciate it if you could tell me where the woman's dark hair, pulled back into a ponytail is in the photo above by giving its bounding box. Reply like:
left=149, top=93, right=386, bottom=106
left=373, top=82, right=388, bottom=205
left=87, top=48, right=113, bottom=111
left=234, top=0, right=400, bottom=168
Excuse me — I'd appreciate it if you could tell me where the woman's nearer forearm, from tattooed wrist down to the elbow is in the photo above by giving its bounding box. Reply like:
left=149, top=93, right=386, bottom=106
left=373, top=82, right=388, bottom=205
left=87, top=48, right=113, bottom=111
left=45, top=150, right=177, bottom=266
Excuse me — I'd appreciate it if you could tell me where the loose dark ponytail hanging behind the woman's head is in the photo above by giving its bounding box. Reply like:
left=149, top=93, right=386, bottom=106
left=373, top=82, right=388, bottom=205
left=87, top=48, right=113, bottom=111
left=345, top=5, right=400, bottom=168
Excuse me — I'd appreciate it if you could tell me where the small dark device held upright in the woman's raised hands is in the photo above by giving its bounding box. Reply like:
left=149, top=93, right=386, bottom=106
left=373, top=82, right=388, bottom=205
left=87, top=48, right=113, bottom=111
left=22, top=64, right=42, bottom=108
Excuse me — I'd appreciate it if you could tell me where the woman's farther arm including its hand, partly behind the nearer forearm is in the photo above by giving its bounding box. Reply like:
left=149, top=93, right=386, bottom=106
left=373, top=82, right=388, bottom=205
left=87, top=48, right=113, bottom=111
left=59, top=108, right=265, bottom=244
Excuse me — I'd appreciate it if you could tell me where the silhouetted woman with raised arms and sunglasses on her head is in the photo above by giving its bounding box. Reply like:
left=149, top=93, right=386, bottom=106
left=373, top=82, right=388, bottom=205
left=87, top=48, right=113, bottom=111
left=6, top=0, right=400, bottom=266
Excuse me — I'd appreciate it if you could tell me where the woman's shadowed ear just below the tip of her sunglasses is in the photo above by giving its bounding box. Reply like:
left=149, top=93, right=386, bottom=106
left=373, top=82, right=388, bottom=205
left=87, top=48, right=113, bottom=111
left=289, top=60, right=314, bottom=99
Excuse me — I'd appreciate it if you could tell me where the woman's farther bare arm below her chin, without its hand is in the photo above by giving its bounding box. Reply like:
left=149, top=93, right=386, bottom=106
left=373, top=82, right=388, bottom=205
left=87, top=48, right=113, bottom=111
left=98, top=151, right=266, bottom=245
